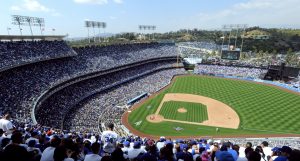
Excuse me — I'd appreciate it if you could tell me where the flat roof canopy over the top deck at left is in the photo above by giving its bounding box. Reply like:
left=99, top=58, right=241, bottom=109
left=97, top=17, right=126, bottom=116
left=0, top=35, right=67, bottom=41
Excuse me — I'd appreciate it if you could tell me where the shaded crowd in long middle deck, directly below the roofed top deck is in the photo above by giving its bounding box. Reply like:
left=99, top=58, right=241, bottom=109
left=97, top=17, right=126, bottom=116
left=0, top=43, right=176, bottom=126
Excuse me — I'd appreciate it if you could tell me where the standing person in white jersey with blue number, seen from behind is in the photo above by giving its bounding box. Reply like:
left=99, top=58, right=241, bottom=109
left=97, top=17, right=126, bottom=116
left=101, top=123, right=118, bottom=154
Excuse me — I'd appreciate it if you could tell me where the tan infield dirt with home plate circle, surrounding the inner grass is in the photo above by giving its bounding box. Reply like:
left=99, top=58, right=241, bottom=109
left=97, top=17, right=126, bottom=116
left=146, top=93, right=240, bottom=129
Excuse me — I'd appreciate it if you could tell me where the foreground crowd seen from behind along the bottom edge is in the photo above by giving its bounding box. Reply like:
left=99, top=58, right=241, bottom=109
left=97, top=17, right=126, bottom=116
left=0, top=116, right=300, bottom=161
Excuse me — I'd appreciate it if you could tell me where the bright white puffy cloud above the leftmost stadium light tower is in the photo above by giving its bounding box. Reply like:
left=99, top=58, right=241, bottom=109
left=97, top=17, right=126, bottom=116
left=10, top=0, right=61, bottom=16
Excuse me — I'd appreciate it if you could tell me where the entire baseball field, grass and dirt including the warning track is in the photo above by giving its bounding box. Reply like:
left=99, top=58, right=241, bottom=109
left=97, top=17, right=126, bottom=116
left=122, top=75, right=300, bottom=138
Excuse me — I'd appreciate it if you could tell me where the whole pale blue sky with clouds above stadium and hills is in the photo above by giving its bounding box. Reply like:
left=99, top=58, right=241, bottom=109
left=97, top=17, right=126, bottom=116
left=0, top=0, right=300, bottom=37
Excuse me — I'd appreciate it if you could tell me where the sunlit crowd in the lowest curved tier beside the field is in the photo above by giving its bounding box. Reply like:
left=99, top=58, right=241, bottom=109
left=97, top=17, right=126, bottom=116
left=64, top=69, right=186, bottom=136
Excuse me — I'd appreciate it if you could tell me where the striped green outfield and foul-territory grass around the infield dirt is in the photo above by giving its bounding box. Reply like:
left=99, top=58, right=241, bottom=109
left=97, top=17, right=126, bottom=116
left=128, top=75, right=300, bottom=136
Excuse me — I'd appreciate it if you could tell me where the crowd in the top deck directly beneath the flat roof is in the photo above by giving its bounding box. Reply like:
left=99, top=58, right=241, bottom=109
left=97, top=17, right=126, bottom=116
left=0, top=41, right=76, bottom=71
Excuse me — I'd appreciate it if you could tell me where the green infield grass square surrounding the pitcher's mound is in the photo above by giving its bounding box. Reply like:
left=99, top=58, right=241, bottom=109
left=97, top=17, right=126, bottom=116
left=159, top=101, right=208, bottom=123
